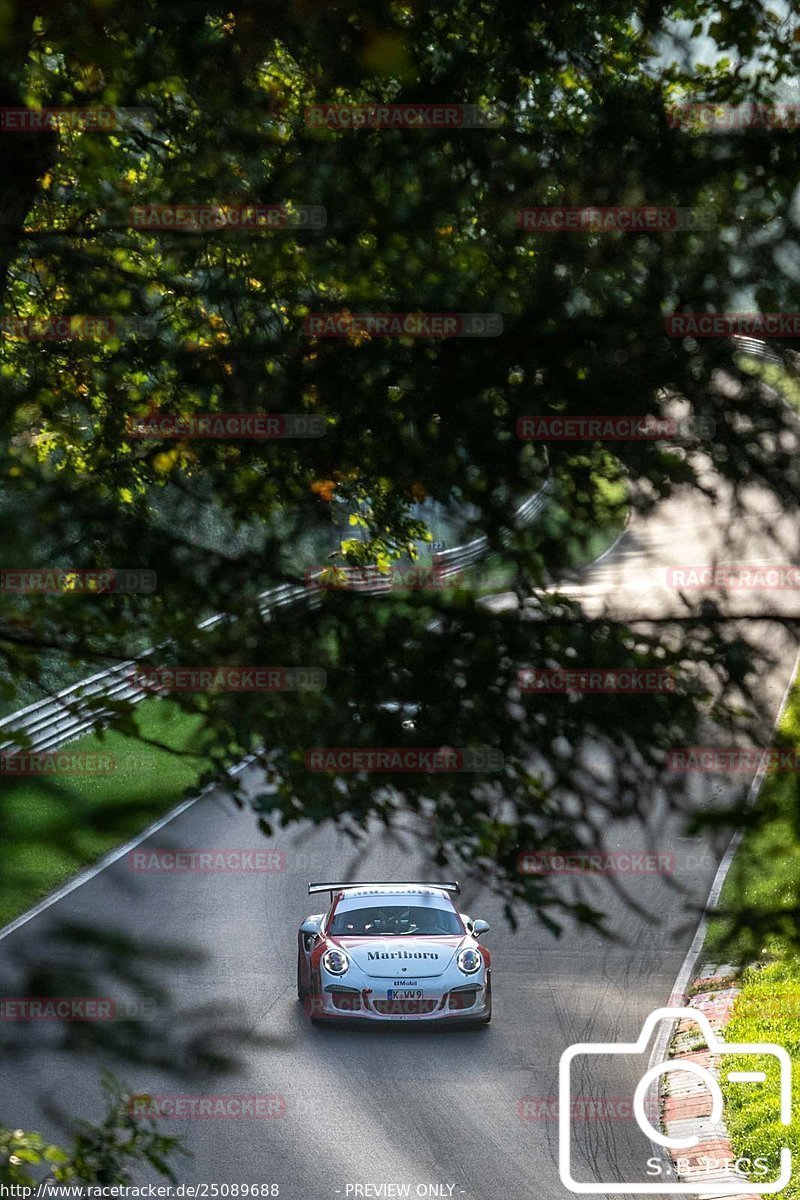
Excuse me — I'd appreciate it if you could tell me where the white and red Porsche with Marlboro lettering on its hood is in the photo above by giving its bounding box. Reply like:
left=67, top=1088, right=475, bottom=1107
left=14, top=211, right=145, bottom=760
left=297, top=883, right=492, bottom=1025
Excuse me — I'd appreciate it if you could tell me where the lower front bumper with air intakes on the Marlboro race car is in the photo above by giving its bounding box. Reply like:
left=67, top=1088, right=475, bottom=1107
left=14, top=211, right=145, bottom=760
left=306, top=977, right=491, bottom=1024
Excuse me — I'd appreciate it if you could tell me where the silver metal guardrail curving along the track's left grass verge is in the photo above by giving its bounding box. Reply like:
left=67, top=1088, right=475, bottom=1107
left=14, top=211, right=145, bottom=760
left=0, top=480, right=551, bottom=754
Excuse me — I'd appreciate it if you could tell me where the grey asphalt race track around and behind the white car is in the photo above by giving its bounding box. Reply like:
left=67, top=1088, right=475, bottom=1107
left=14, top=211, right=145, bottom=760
left=0, top=468, right=798, bottom=1200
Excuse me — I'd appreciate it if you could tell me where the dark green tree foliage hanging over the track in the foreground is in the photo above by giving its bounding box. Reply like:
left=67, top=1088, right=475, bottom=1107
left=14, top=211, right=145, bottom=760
left=0, top=0, right=800, bottom=919
